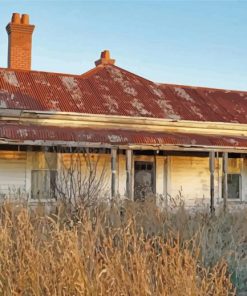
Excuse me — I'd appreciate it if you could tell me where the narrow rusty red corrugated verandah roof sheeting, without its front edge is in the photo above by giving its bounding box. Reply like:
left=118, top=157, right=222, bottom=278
left=0, top=121, right=247, bottom=148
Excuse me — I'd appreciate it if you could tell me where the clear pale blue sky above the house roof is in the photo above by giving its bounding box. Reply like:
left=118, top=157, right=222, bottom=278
left=0, top=0, right=247, bottom=90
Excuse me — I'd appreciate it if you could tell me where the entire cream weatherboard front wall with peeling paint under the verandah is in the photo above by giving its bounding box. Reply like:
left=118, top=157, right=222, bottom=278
left=0, top=151, right=247, bottom=206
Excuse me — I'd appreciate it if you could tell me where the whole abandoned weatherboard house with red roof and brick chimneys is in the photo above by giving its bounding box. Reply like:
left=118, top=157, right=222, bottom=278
left=0, top=13, right=247, bottom=210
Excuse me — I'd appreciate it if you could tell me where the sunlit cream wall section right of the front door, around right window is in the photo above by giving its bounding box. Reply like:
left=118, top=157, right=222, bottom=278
left=168, top=156, right=244, bottom=206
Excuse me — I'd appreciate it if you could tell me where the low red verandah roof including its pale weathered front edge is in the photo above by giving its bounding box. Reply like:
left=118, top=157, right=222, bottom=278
left=0, top=121, right=247, bottom=151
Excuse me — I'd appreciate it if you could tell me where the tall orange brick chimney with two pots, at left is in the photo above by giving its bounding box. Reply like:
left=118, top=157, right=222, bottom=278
left=6, top=13, right=34, bottom=70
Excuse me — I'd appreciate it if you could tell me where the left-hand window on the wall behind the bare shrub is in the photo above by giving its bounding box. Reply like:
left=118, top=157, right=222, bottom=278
left=31, top=170, right=57, bottom=200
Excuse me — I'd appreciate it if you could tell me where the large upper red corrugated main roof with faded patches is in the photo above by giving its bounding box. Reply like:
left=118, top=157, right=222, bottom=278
left=0, top=65, right=247, bottom=124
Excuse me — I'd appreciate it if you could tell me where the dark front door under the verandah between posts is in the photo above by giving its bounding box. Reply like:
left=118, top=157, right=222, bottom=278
left=134, top=161, right=154, bottom=200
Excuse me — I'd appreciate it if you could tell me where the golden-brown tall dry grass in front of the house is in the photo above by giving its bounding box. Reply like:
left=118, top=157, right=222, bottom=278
left=0, top=203, right=235, bottom=296
